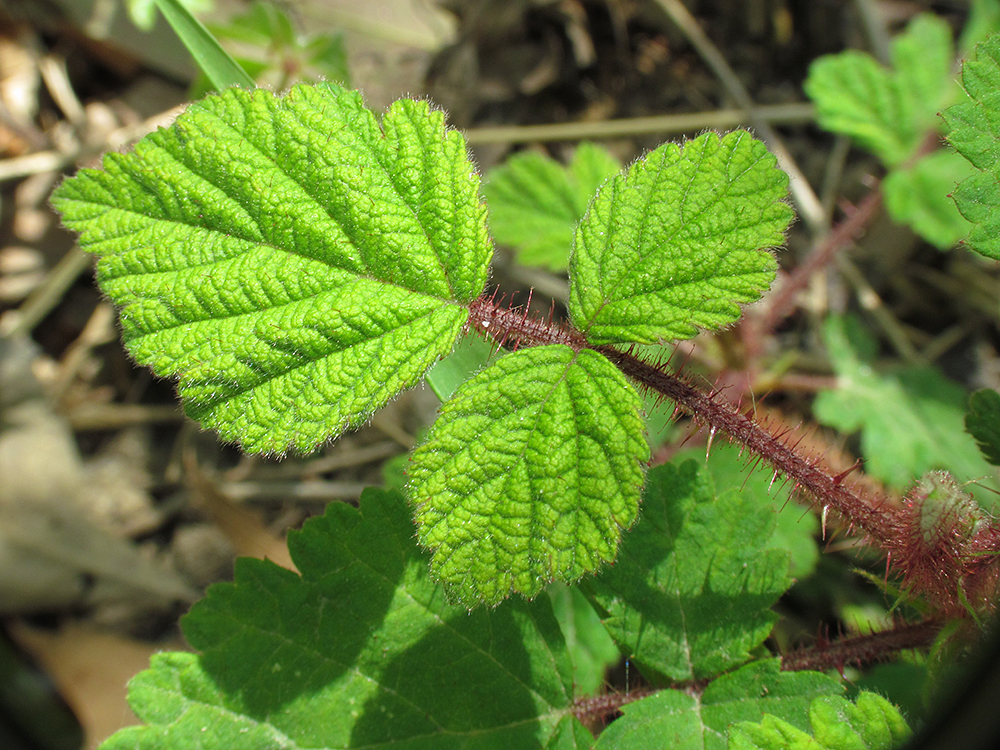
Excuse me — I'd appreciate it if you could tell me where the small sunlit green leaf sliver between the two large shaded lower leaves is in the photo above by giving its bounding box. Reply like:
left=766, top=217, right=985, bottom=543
left=547, top=583, right=621, bottom=697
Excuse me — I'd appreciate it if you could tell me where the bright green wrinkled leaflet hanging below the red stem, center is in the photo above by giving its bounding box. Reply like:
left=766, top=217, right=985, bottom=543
left=409, top=346, right=649, bottom=607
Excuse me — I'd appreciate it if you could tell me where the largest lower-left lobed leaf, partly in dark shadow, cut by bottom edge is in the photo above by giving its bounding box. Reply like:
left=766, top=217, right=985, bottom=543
left=97, top=490, right=590, bottom=750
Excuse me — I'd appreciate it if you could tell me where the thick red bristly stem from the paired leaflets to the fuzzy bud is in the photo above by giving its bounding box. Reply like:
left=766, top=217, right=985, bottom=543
left=597, top=346, right=905, bottom=550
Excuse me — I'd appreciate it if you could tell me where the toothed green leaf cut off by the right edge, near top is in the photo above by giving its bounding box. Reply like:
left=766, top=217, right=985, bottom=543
left=944, top=36, right=1000, bottom=260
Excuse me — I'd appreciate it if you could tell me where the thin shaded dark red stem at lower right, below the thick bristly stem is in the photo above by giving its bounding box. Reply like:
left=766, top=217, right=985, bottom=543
left=781, top=620, right=942, bottom=672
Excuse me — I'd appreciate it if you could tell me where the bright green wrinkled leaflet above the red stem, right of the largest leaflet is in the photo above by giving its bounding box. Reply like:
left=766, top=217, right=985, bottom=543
left=569, top=131, right=792, bottom=344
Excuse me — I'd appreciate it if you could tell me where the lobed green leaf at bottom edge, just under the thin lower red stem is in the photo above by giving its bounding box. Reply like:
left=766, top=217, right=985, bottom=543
left=597, top=659, right=843, bottom=750
